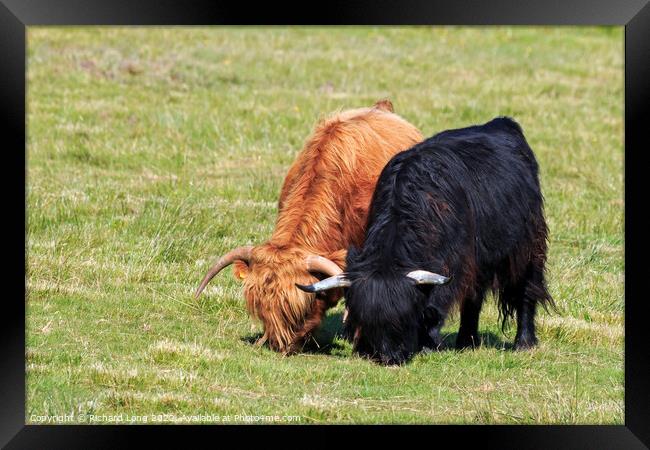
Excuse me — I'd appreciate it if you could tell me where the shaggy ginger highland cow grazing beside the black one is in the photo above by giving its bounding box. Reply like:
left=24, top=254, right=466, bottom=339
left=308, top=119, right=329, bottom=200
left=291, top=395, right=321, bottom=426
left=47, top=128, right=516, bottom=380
left=196, top=100, right=422, bottom=353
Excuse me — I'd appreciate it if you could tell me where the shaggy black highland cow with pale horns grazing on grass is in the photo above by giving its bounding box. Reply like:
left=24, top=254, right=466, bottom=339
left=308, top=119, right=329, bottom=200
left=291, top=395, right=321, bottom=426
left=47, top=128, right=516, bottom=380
left=299, top=118, right=553, bottom=364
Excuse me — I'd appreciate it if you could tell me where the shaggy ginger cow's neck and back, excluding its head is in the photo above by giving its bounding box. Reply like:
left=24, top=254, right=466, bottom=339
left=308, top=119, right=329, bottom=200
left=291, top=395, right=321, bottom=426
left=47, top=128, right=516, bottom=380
left=272, top=104, right=422, bottom=254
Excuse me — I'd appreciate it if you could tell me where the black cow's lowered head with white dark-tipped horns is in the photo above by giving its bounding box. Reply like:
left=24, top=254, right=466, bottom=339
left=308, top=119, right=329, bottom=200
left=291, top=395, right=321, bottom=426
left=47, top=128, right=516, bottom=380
left=298, top=251, right=450, bottom=364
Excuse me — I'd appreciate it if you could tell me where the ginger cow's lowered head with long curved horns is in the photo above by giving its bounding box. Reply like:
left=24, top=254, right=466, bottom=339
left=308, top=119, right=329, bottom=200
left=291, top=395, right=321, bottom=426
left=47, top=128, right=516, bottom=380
left=195, top=243, right=344, bottom=352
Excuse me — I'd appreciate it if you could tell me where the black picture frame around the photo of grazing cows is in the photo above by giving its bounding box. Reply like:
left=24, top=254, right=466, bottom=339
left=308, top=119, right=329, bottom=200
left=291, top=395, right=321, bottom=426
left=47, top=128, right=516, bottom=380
left=0, top=0, right=650, bottom=449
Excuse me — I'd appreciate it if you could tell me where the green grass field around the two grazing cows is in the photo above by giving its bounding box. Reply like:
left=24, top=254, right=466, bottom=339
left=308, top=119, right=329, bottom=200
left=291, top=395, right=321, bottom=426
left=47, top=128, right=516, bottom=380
left=26, top=27, right=624, bottom=424
